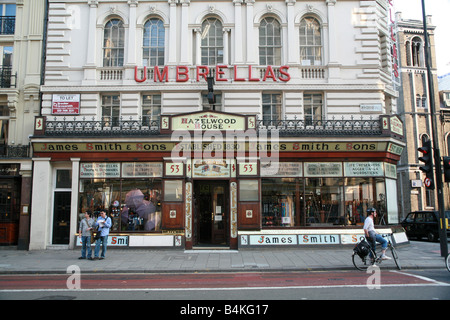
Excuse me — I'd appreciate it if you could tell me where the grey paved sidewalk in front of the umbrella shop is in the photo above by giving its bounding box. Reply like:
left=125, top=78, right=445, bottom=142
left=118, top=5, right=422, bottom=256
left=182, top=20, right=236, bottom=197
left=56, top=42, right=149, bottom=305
left=0, top=241, right=445, bottom=274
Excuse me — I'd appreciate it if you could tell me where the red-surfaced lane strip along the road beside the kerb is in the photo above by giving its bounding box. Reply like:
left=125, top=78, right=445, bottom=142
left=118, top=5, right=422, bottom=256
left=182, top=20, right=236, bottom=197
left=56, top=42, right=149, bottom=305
left=0, top=271, right=445, bottom=290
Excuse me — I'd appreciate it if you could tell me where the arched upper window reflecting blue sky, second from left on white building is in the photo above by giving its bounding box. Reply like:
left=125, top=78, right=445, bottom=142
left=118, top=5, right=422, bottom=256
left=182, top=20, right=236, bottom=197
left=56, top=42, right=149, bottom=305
left=142, top=18, right=165, bottom=66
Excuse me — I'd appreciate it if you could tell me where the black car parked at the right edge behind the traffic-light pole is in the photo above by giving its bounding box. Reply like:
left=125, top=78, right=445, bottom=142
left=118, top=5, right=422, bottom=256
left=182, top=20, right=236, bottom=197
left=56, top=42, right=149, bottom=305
left=401, top=211, right=450, bottom=241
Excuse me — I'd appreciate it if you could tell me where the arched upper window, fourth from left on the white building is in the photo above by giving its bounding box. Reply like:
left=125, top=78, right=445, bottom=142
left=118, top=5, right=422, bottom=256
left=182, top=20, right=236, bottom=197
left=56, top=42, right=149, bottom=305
left=259, top=17, right=281, bottom=66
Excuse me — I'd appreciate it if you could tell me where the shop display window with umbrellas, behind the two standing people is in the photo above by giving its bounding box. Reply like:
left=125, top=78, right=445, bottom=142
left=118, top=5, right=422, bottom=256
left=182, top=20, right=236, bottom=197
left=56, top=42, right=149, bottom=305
left=78, top=163, right=162, bottom=232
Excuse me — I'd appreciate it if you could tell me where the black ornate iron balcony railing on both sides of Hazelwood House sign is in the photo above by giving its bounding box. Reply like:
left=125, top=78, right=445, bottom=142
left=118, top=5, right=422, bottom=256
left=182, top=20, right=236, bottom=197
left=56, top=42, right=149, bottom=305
left=44, top=117, right=383, bottom=137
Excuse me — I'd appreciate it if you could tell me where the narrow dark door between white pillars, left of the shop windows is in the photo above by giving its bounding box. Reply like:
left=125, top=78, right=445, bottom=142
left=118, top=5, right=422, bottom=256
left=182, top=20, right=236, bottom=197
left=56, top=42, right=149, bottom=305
left=53, top=192, right=71, bottom=244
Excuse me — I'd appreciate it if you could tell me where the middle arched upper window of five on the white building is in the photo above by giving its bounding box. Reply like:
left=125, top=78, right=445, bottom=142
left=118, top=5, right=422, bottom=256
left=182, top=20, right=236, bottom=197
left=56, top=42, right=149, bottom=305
left=200, top=18, right=224, bottom=66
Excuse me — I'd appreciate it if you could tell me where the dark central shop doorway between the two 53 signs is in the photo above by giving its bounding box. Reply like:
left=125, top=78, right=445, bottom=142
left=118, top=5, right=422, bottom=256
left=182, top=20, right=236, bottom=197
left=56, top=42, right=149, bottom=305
left=194, top=180, right=229, bottom=247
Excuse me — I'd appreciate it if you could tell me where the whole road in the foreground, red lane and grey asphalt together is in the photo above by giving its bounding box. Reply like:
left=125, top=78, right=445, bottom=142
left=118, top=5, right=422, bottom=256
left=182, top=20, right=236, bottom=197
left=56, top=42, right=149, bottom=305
left=0, top=268, right=450, bottom=304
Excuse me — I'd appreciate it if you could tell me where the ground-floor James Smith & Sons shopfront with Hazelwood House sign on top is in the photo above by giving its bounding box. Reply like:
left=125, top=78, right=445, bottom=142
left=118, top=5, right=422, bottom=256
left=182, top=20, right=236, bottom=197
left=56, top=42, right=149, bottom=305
left=33, top=111, right=404, bottom=249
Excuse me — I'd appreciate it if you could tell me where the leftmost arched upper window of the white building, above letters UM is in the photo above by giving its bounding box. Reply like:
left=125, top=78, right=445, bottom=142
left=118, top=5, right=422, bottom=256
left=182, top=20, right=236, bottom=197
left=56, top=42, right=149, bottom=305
left=103, top=19, right=125, bottom=67
